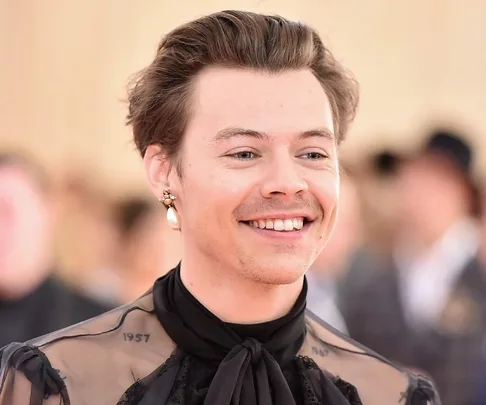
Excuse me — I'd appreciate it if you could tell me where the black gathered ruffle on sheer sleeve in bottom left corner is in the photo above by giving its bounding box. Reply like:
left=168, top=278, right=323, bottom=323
left=0, top=343, right=70, bottom=405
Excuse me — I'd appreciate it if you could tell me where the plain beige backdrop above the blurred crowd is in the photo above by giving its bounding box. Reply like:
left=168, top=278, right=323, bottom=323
left=0, top=0, right=486, bottom=194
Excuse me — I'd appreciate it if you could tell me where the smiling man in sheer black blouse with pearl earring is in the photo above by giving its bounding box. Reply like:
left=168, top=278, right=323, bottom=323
left=2, top=11, right=438, bottom=405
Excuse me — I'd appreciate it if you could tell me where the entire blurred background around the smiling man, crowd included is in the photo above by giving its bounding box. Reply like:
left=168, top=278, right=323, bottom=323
left=4, top=4, right=486, bottom=405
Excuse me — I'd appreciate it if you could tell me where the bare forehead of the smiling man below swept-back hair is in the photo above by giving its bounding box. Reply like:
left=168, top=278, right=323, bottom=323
left=188, top=67, right=333, bottom=136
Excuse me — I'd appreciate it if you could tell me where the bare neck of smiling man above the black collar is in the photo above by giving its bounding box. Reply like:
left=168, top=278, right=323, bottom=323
left=181, top=252, right=304, bottom=324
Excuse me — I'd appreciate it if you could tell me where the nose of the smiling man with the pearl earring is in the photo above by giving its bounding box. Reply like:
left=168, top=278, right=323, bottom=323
left=261, top=158, right=308, bottom=198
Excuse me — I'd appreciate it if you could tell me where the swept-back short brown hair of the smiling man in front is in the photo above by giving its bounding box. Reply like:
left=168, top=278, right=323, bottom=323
left=127, top=11, right=358, bottom=166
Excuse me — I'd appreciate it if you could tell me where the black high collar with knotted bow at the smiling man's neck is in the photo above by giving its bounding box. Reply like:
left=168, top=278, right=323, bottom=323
left=153, top=268, right=306, bottom=405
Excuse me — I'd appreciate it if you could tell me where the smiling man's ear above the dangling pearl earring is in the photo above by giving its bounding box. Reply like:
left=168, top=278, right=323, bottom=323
left=143, top=145, right=170, bottom=198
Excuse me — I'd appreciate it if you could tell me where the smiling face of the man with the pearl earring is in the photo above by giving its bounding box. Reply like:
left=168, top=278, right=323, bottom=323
left=148, top=68, right=339, bottom=284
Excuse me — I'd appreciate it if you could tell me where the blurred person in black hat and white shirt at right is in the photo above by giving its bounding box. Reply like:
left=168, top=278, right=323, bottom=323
left=343, top=130, right=486, bottom=405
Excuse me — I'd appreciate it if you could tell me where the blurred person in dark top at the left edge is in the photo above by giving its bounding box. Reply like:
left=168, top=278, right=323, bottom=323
left=0, top=154, right=109, bottom=346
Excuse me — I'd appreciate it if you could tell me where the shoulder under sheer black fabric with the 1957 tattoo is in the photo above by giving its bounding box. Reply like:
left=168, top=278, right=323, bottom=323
left=0, top=294, right=174, bottom=405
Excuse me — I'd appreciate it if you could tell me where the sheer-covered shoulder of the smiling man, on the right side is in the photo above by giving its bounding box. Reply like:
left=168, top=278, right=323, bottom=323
left=301, top=311, right=440, bottom=405
